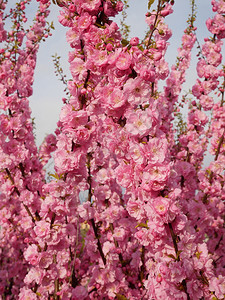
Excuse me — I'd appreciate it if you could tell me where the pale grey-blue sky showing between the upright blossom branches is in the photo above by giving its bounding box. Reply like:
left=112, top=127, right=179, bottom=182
left=20, top=0, right=213, bottom=145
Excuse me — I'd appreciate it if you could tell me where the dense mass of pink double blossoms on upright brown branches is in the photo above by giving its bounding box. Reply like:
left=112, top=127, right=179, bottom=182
left=0, top=0, right=225, bottom=300
